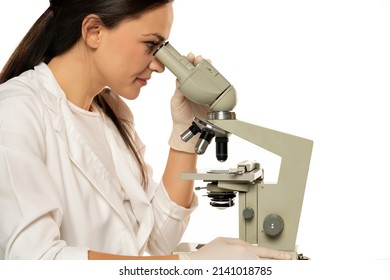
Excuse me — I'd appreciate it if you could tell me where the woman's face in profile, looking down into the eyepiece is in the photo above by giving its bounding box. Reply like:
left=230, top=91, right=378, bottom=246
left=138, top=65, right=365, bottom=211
left=92, top=3, right=173, bottom=99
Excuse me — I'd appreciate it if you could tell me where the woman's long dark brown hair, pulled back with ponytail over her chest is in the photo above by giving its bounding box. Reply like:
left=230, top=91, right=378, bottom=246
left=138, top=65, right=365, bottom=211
left=0, top=0, right=173, bottom=186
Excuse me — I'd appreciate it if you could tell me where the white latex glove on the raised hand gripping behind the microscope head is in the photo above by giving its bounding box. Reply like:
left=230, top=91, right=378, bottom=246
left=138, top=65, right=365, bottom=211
left=168, top=53, right=208, bottom=153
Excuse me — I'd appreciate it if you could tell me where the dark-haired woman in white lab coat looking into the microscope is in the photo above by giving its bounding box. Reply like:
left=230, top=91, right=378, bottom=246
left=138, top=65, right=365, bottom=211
left=0, top=0, right=290, bottom=259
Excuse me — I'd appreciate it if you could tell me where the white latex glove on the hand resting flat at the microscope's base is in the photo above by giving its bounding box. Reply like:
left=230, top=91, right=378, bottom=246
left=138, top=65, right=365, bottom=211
left=179, top=237, right=291, bottom=260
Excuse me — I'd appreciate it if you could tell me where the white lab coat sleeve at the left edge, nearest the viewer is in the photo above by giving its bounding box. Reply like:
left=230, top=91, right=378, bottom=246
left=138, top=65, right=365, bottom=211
left=0, top=93, right=88, bottom=259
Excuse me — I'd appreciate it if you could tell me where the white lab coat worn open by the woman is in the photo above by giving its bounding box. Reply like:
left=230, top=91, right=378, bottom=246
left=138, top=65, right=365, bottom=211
left=0, top=63, right=197, bottom=259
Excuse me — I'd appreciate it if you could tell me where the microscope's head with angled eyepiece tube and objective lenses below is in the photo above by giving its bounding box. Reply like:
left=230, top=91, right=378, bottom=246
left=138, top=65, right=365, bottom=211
left=153, top=42, right=236, bottom=161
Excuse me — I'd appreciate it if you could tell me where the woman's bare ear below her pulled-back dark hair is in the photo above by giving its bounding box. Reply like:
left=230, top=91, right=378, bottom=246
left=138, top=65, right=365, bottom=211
left=81, top=14, right=104, bottom=49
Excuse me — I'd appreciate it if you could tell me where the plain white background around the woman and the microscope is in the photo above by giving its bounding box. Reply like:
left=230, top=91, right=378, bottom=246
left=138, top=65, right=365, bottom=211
left=0, top=0, right=390, bottom=260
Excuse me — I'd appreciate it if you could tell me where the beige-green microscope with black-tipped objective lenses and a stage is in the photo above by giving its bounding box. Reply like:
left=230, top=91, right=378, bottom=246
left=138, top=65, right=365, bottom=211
left=154, top=42, right=313, bottom=259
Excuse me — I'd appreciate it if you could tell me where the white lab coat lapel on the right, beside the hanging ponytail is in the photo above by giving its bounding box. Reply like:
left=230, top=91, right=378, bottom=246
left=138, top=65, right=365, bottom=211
left=106, top=124, right=154, bottom=253
